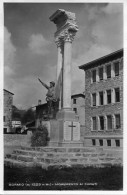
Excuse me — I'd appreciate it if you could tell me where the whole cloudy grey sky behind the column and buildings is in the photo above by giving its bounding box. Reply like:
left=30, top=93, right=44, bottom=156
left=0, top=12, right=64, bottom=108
left=4, top=3, right=123, bottom=109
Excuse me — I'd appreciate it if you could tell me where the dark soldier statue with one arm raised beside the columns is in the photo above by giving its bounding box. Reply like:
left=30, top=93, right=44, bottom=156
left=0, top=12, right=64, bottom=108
left=38, top=78, right=57, bottom=116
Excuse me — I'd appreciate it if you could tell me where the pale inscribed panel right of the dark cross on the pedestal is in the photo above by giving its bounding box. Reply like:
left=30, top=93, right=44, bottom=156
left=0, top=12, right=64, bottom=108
left=73, top=122, right=80, bottom=141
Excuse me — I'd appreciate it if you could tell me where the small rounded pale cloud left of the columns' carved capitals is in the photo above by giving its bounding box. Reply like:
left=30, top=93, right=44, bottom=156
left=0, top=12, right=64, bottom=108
left=28, top=34, right=50, bottom=55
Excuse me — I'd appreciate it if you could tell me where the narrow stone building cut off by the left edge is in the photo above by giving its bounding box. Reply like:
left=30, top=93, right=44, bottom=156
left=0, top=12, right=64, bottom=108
left=3, top=89, right=14, bottom=133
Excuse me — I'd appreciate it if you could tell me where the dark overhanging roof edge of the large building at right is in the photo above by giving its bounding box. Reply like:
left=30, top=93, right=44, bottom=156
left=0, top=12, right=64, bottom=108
left=79, top=49, right=123, bottom=70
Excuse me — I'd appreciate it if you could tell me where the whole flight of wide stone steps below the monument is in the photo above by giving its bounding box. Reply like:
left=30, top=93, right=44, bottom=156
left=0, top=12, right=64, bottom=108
left=5, top=146, right=122, bottom=169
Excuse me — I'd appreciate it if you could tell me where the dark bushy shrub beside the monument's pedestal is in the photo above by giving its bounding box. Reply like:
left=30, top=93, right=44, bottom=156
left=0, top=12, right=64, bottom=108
left=31, top=126, right=49, bottom=147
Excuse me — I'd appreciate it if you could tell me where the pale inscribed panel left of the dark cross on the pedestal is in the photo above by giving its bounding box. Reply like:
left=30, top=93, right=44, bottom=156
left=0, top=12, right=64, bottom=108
left=64, top=121, right=71, bottom=141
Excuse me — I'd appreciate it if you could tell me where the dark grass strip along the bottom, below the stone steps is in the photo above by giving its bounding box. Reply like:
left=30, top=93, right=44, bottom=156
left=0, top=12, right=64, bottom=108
left=4, top=167, right=123, bottom=190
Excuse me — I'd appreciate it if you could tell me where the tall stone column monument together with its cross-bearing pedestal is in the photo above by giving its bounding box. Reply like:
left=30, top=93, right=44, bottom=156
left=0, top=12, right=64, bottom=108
left=37, top=9, right=83, bottom=147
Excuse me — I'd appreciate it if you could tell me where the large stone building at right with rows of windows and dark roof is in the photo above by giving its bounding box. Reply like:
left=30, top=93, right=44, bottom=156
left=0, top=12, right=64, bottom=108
left=79, top=49, right=123, bottom=147
